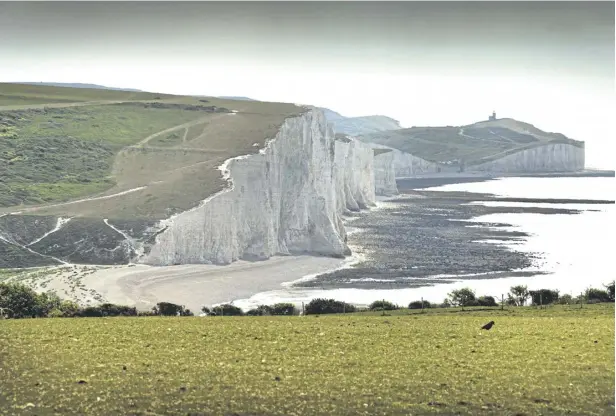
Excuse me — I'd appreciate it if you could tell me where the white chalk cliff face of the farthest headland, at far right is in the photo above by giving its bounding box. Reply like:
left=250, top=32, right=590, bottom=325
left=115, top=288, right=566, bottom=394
left=468, top=143, right=584, bottom=173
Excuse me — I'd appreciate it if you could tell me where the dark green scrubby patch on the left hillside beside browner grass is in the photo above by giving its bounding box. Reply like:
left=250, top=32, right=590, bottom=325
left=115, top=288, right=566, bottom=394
left=0, top=105, right=215, bottom=206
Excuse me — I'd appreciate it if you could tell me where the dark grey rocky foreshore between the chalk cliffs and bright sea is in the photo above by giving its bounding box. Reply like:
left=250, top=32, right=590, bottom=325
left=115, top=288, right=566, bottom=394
left=294, top=177, right=614, bottom=289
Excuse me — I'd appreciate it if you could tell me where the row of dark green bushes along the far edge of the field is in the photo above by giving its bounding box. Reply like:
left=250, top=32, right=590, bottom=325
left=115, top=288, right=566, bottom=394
left=0, top=281, right=614, bottom=319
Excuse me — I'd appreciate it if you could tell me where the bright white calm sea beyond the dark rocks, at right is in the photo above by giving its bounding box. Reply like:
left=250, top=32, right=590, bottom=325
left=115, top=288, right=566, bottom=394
left=234, top=177, right=616, bottom=308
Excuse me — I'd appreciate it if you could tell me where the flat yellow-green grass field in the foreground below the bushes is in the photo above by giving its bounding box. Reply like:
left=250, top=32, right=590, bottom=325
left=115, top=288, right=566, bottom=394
left=0, top=304, right=614, bottom=415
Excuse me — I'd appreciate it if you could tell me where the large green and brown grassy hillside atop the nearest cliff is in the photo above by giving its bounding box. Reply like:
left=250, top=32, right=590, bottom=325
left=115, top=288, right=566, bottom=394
left=0, top=84, right=303, bottom=218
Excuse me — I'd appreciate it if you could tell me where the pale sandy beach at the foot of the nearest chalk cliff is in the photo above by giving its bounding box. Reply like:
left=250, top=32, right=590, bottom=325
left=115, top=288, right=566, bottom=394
left=14, top=256, right=348, bottom=313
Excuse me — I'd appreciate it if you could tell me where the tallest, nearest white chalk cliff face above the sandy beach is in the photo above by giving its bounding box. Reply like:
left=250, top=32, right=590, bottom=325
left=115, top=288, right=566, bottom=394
left=141, top=110, right=356, bottom=265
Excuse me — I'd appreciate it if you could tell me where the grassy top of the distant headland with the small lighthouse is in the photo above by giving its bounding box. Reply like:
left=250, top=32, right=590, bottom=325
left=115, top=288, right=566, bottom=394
left=361, top=118, right=584, bottom=165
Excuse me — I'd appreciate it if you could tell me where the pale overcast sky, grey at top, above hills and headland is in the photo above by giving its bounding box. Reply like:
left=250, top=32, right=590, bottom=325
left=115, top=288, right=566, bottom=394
left=0, top=2, right=616, bottom=168
